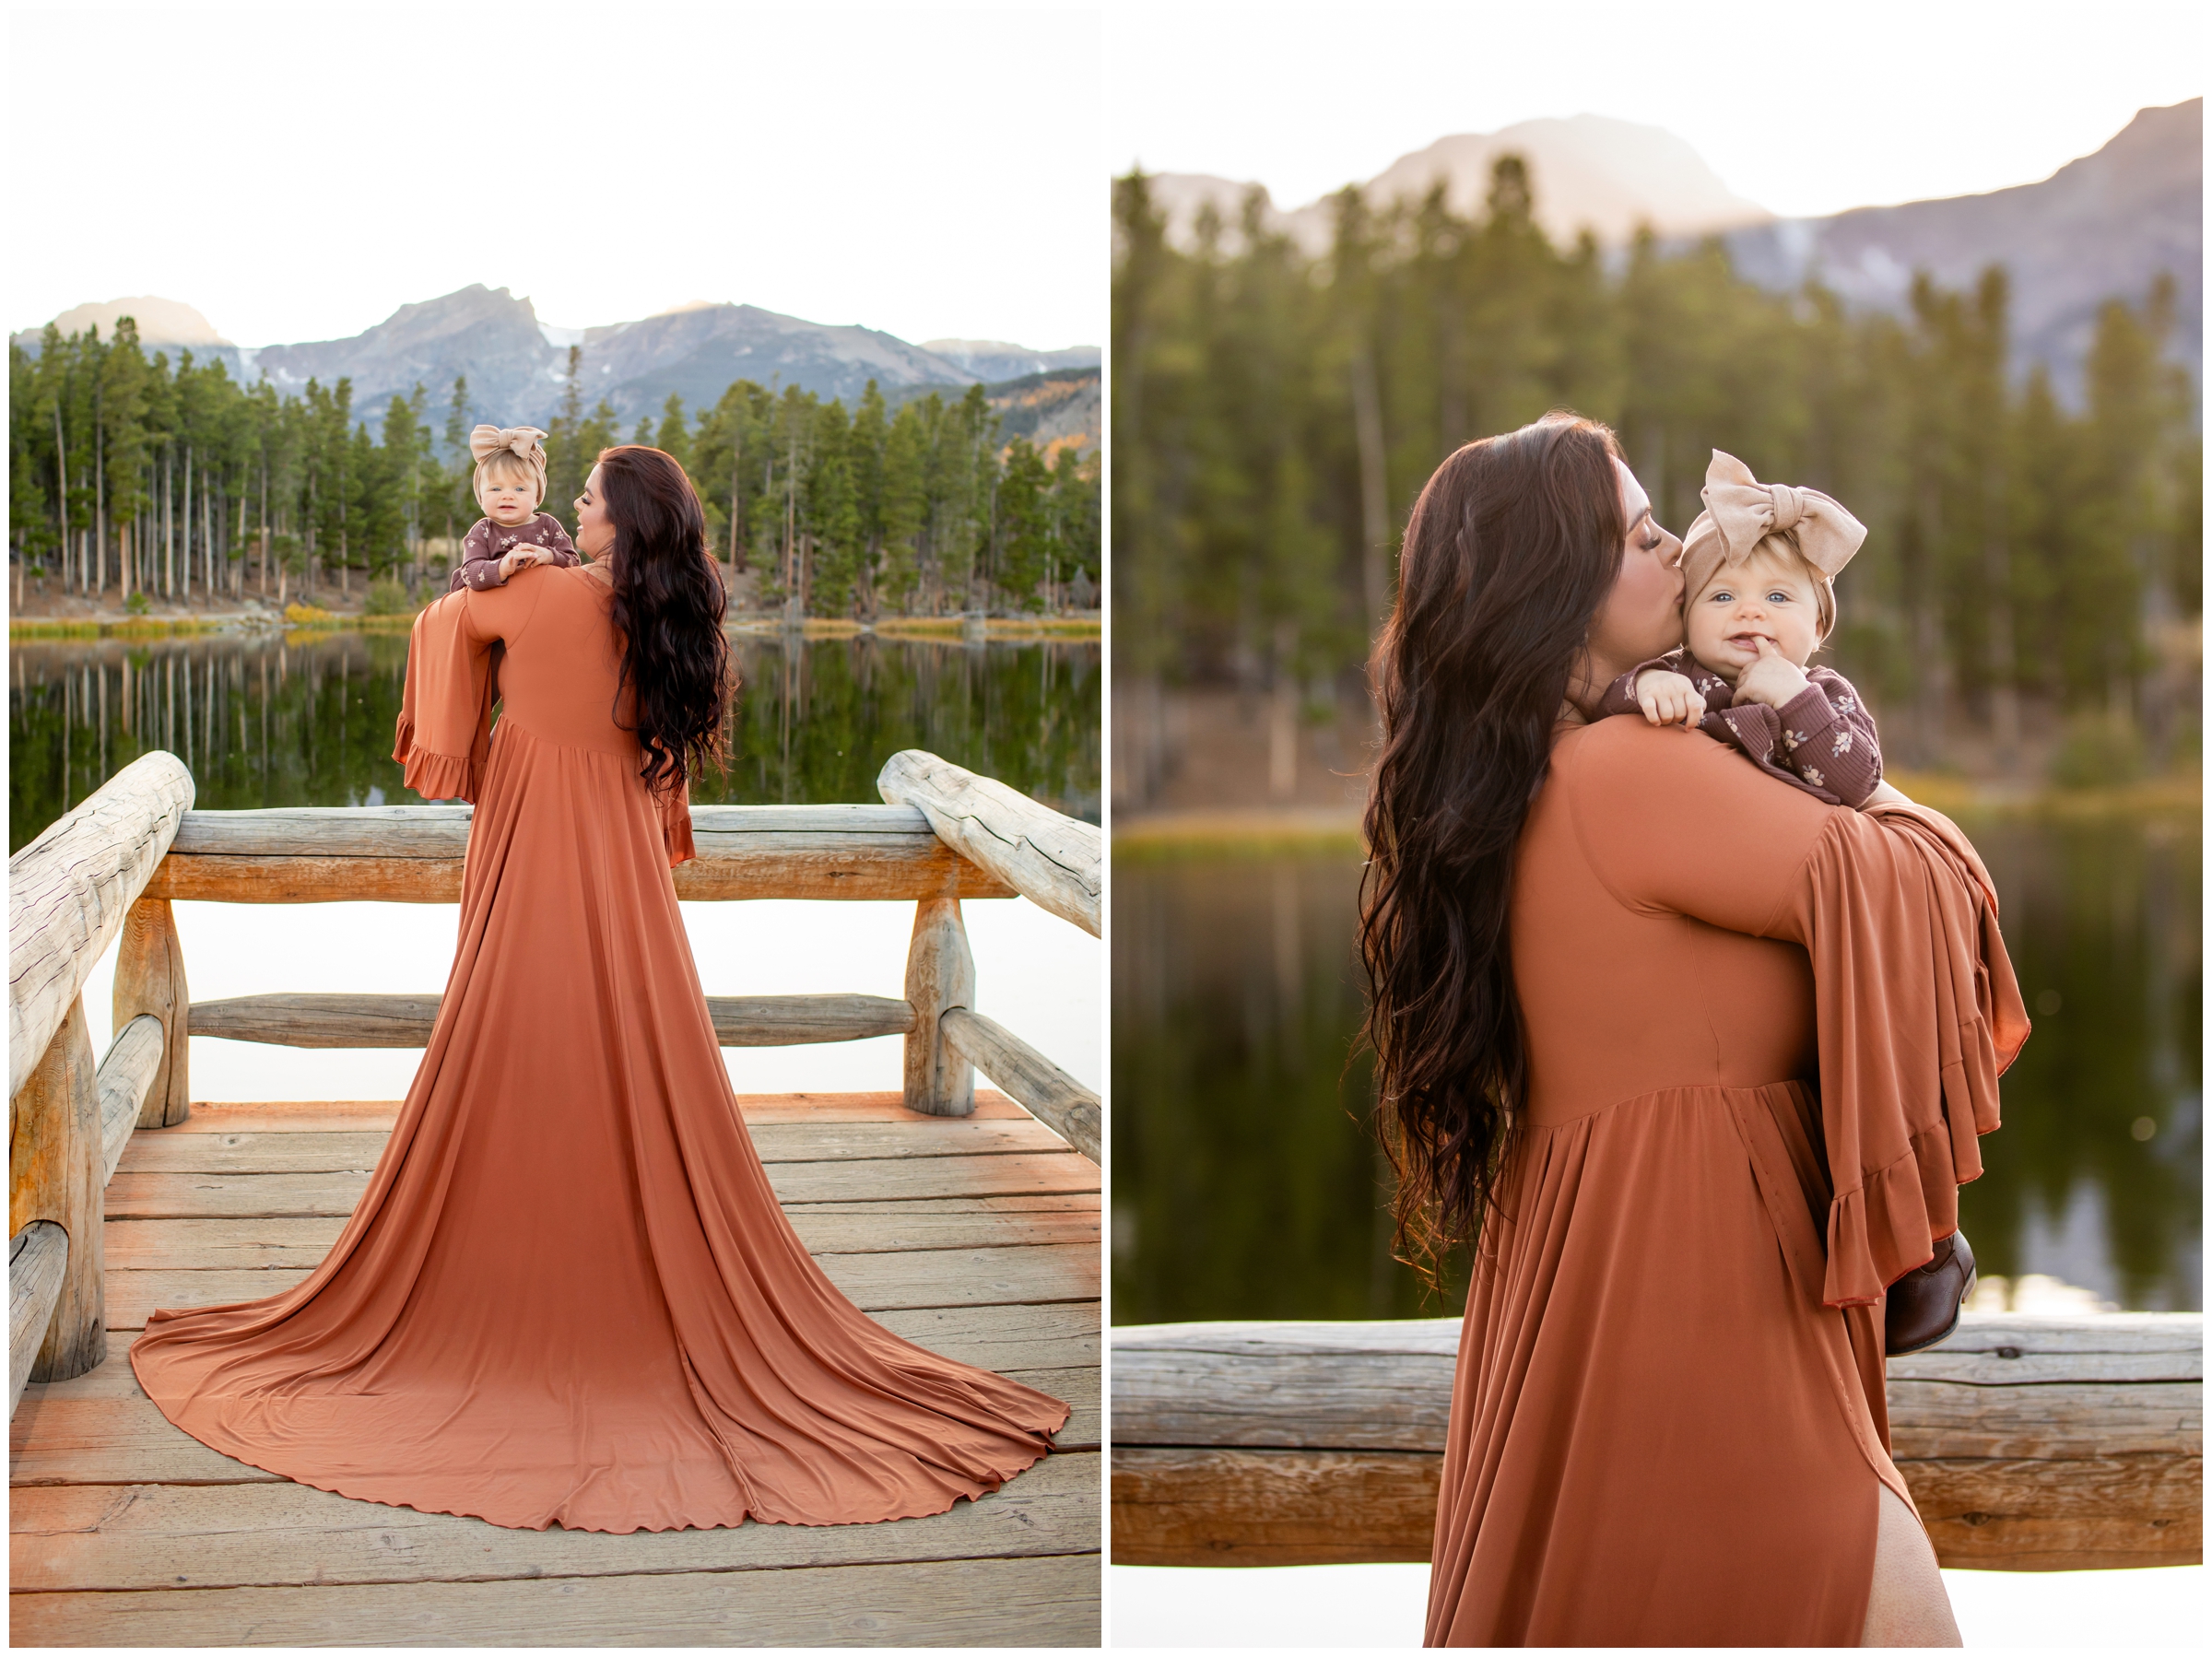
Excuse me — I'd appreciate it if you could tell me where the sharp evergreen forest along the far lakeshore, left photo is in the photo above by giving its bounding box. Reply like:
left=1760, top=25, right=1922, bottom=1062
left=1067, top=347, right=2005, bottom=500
left=9, top=329, right=1101, bottom=619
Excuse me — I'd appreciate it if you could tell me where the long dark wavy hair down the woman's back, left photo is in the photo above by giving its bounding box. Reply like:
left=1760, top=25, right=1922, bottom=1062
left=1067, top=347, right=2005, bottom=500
left=599, top=442, right=736, bottom=794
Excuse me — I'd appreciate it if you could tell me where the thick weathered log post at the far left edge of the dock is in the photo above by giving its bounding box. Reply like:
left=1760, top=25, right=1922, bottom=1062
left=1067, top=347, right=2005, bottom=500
left=6, top=998, right=109, bottom=1396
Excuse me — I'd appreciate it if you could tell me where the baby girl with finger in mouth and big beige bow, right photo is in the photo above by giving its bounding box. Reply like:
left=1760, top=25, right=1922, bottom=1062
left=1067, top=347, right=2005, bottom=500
left=1604, top=449, right=1882, bottom=805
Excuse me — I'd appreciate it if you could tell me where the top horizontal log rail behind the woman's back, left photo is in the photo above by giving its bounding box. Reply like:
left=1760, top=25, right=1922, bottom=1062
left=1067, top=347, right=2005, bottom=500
left=146, top=805, right=1021, bottom=902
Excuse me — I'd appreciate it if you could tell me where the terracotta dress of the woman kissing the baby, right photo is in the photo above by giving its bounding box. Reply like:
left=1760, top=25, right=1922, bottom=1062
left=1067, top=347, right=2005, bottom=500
left=1427, top=719, right=2029, bottom=1646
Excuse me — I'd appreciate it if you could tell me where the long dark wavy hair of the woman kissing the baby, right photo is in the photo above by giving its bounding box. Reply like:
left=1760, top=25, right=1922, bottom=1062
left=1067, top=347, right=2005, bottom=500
left=1360, top=414, right=1628, bottom=1283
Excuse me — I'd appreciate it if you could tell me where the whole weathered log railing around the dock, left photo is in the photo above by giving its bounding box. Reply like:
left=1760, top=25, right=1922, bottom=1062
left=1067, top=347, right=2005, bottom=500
left=9, top=750, right=1101, bottom=1414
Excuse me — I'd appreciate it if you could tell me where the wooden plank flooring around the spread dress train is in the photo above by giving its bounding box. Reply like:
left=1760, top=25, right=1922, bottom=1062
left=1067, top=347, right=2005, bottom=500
left=9, top=1093, right=1104, bottom=1646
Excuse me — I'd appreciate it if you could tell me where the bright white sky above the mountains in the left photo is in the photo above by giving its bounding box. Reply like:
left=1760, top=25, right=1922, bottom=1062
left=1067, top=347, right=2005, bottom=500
left=0, top=0, right=1111, bottom=349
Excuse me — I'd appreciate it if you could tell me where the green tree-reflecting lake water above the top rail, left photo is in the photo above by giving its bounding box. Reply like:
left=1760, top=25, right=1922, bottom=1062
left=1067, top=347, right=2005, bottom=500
left=9, top=633, right=1100, bottom=854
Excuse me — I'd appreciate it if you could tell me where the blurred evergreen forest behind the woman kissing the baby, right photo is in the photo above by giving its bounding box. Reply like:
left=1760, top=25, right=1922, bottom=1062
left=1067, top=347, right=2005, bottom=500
left=1112, top=157, right=2203, bottom=774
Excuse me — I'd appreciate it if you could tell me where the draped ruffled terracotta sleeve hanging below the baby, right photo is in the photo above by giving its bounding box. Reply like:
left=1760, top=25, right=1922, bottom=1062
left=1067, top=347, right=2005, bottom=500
left=1776, top=805, right=2029, bottom=1305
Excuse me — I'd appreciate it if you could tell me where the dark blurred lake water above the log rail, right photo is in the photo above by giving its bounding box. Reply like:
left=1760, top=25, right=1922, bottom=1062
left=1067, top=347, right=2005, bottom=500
left=1112, top=818, right=2203, bottom=1323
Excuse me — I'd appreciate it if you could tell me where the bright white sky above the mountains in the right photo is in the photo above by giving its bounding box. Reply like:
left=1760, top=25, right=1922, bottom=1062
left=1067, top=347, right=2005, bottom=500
left=1106, top=0, right=2206, bottom=217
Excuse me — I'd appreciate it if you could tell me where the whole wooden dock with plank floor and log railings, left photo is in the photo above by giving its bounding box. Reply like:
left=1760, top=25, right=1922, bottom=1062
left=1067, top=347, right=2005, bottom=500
left=9, top=750, right=1104, bottom=1646
